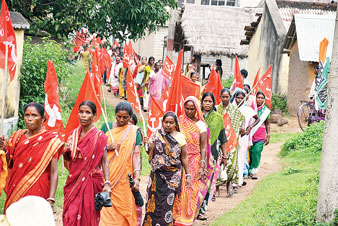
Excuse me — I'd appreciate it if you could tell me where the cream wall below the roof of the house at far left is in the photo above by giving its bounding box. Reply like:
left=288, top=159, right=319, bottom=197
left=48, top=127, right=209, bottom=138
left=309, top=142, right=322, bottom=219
left=0, top=30, right=24, bottom=134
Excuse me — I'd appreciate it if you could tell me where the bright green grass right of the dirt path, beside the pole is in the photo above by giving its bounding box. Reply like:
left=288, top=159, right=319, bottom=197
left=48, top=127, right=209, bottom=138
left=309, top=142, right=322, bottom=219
left=212, top=133, right=321, bottom=226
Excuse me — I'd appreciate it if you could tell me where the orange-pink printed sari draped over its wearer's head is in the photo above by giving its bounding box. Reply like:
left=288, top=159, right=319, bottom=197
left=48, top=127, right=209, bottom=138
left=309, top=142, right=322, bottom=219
left=174, top=97, right=214, bottom=225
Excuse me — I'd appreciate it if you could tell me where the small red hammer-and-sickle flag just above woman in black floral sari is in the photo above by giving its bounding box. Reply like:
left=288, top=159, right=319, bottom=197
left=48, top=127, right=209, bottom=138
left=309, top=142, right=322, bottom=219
left=147, top=97, right=164, bottom=137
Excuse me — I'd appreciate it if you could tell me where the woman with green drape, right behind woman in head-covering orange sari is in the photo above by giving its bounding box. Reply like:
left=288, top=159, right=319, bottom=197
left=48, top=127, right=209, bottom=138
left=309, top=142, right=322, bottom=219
left=197, top=92, right=227, bottom=220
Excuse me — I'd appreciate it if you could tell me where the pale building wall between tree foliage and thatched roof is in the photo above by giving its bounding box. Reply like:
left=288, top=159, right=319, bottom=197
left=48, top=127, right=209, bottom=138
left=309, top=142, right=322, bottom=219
left=132, top=26, right=168, bottom=61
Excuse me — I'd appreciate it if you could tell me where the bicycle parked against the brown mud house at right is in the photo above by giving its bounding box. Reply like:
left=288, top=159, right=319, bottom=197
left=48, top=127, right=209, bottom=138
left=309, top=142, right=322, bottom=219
left=297, top=100, right=325, bottom=131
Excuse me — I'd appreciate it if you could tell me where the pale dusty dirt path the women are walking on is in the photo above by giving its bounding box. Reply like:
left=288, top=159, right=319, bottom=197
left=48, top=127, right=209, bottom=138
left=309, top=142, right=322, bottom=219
left=56, top=87, right=301, bottom=226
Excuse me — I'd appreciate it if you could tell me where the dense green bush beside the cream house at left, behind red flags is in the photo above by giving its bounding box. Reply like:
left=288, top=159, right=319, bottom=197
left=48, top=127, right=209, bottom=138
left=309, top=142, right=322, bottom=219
left=18, top=39, right=70, bottom=128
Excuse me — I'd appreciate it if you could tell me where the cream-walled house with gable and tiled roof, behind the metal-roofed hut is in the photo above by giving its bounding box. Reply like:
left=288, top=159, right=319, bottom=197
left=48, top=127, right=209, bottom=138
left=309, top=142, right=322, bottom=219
left=241, top=0, right=337, bottom=95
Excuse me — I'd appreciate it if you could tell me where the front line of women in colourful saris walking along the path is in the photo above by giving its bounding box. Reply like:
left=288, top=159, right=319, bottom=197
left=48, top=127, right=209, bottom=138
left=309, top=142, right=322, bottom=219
left=0, top=81, right=270, bottom=226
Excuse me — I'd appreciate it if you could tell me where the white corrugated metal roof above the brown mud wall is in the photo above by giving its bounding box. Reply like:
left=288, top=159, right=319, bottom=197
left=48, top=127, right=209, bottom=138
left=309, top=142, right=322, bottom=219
left=295, top=14, right=336, bottom=62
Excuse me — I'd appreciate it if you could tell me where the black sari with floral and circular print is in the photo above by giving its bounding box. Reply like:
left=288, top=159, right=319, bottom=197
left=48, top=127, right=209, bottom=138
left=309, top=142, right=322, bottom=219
left=143, top=128, right=182, bottom=226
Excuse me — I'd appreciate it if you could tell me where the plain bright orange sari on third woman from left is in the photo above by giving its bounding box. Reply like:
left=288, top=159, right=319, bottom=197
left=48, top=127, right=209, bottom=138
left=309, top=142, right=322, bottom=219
left=100, top=124, right=138, bottom=226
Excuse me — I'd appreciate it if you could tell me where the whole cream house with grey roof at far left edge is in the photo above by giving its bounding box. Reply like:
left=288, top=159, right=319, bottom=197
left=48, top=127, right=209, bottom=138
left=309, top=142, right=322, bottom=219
left=0, top=12, right=29, bottom=135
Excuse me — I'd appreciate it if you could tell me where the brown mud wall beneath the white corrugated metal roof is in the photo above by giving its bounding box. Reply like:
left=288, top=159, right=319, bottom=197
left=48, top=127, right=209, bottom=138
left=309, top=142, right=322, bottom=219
left=287, top=42, right=314, bottom=115
